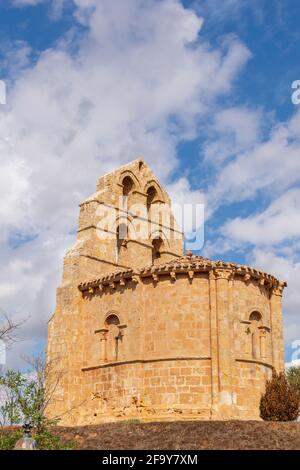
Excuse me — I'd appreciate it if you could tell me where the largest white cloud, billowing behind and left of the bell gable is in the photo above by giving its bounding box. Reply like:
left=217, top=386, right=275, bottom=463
left=0, top=0, right=249, bottom=368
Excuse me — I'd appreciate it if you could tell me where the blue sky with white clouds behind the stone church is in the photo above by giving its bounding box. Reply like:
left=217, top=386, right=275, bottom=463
left=0, top=0, right=300, bottom=367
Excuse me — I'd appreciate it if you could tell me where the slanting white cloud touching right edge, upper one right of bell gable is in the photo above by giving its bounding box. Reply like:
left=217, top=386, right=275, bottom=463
left=211, top=112, right=300, bottom=207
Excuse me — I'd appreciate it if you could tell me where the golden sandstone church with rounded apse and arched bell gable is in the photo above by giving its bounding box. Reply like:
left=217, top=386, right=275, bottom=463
left=47, top=160, right=286, bottom=425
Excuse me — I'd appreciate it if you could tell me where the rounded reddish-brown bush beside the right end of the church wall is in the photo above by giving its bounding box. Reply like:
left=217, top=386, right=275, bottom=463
left=260, top=371, right=300, bottom=421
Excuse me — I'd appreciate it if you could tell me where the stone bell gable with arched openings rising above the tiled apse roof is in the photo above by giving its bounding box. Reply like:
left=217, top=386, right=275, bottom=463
left=74, top=160, right=183, bottom=280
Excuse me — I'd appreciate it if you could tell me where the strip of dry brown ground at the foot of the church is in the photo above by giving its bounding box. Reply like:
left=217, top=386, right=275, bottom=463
left=55, top=421, right=300, bottom=450
